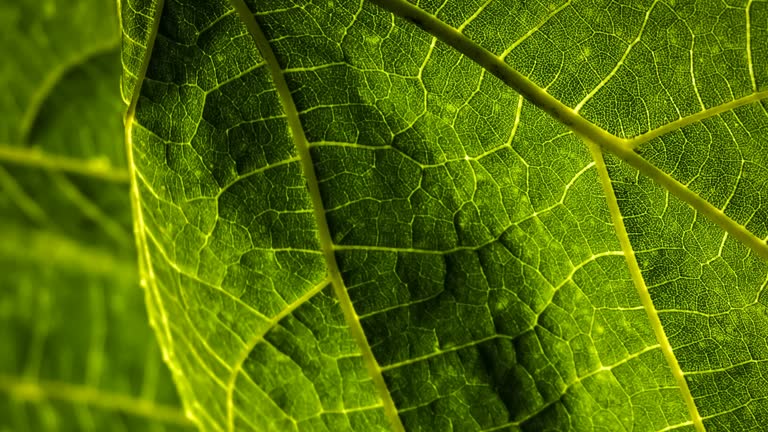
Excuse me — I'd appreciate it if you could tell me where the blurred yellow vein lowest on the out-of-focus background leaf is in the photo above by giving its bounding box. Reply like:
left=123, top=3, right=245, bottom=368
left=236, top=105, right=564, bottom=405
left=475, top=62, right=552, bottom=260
left=0, top=375, right=192, bottom=426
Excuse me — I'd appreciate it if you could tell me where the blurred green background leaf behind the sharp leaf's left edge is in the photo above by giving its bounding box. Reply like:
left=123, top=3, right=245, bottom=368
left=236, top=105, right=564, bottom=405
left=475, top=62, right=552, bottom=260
left=0, top=0, right=192, bottom=431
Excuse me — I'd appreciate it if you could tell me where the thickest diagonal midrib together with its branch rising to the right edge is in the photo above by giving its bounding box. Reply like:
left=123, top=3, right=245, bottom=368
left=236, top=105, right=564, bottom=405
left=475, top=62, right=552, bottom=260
left=370, top=0, right=768, bottom=259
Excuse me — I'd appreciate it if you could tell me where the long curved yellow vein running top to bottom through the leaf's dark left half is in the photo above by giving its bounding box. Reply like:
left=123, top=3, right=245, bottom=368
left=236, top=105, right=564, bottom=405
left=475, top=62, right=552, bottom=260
left=230, top=0, right=405, bottom=432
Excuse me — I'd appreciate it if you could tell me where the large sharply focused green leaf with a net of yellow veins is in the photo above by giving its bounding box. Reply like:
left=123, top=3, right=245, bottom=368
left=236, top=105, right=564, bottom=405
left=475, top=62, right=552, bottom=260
left=122, top=0, right=768, bottom=432
